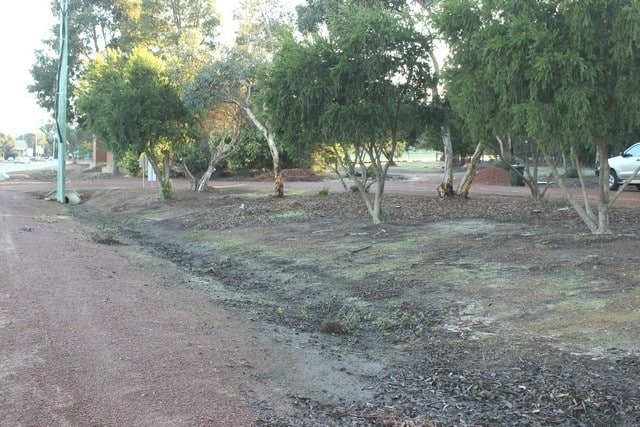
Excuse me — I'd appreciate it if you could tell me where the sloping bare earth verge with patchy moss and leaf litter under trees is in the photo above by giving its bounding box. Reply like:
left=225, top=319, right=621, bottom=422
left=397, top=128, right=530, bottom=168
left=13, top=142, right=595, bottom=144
left=74, top=182, right=640, bottom=425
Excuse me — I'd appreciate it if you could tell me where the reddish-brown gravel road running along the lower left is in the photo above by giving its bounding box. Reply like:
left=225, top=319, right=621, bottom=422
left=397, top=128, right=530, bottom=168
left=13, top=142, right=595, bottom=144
left=0, top=191, right=296, bottom=426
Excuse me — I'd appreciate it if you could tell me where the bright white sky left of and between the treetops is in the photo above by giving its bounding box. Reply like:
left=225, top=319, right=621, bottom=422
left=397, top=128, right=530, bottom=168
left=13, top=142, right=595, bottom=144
left=0, top=0, right=300, bottom=138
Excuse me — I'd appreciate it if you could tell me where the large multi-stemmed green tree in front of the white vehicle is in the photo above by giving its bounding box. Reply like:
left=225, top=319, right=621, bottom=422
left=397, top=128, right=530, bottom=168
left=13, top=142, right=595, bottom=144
left=437, top=0, right=640, bottom=234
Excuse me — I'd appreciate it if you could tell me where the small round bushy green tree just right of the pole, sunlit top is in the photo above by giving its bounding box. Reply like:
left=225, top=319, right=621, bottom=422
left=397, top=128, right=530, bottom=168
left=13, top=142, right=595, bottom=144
left=76, top=48, right=191, bottom=198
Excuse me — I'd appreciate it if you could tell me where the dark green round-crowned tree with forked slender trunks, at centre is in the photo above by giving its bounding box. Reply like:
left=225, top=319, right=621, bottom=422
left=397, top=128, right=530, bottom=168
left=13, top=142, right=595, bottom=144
left=263, top=5, right=433, bottom=223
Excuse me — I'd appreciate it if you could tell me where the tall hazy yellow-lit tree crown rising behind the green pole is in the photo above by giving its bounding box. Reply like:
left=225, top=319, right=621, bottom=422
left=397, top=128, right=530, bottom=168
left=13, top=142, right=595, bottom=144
left=29, top=0, right=220, bottom=122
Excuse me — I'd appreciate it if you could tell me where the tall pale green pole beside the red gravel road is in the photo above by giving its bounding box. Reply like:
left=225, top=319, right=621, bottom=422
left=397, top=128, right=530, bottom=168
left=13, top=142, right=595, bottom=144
left=56, top=0, right=69, bottom=203
